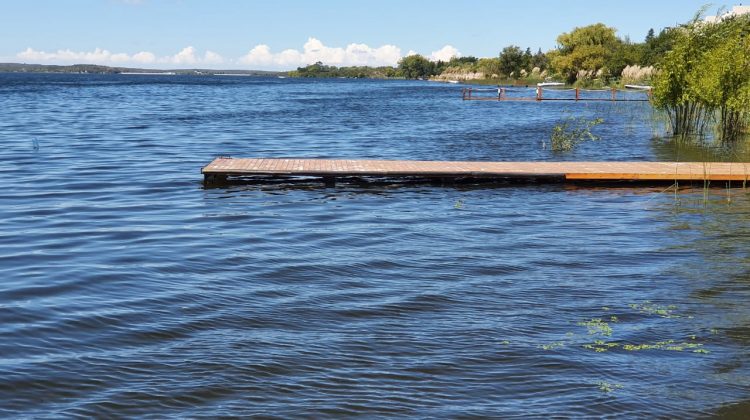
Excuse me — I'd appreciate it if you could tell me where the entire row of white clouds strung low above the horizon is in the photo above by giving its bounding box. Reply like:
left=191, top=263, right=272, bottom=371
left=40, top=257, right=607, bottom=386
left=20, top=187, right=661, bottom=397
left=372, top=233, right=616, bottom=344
left=16, top=37, right=461, bottom=70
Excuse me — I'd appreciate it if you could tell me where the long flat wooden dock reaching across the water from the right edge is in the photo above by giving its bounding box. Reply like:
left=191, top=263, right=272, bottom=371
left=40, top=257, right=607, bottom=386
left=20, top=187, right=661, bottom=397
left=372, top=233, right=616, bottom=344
left=201, top=157, right=750, bottom=185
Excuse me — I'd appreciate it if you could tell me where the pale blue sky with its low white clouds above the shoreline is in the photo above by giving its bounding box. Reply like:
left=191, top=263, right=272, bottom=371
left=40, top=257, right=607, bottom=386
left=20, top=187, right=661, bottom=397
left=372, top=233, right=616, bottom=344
left=0, top=0, right=736, bottom=70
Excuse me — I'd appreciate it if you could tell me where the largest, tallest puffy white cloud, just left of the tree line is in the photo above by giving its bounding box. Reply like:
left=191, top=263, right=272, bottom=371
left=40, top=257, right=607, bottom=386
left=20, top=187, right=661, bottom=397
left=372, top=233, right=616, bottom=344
left=239, top=38, right=402, bottom=69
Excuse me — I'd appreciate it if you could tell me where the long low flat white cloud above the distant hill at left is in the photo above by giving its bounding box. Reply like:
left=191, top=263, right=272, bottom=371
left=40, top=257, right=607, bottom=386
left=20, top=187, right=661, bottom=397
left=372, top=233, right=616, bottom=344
left=16, top=46, right=224, bottom=67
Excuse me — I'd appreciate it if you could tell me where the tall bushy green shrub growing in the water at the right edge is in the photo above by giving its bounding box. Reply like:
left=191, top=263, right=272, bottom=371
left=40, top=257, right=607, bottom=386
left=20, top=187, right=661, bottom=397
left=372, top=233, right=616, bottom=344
left=653, top=9, right=750, bottom=141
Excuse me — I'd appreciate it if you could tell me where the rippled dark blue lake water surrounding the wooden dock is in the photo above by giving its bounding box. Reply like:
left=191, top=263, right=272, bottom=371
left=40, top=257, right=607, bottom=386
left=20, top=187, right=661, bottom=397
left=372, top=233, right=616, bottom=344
left=0, top=74, right=750, bottom=418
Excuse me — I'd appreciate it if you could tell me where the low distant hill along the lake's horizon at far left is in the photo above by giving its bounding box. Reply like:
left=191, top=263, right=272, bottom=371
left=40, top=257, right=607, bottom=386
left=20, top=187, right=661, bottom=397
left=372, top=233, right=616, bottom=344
left=0, top=63, right=286, bottom=76
